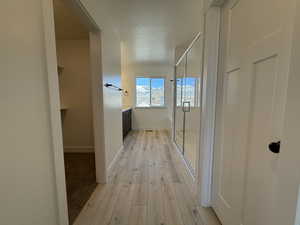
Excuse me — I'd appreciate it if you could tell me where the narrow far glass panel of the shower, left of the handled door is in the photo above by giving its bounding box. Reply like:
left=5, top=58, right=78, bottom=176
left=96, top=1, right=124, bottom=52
left=175, top=58, right=186, bottom=153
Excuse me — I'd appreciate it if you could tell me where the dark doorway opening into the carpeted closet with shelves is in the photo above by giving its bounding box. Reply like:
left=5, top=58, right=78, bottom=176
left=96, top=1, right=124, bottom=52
left=53, top=0, right=97, bottom=221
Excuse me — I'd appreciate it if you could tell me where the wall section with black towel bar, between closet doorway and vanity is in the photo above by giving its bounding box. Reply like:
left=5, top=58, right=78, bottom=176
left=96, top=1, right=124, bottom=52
left=81, top=0, right=123, bottom=168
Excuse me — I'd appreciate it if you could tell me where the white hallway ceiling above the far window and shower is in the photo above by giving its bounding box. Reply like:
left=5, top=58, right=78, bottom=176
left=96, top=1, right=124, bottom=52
left=110, top=0, right=203, bottom=64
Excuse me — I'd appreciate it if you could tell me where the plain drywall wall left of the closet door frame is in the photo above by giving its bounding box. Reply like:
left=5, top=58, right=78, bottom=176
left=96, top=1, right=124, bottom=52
left=0, top=0, right=58, bottom=225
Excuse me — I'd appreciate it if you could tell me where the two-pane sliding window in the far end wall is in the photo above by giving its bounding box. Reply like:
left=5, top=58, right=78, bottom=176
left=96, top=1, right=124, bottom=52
left=136, top=77, right=165, bottom=107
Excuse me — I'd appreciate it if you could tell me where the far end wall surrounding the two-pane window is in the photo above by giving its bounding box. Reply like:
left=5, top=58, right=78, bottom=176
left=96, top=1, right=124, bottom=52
left=122, top=62, right=174, bottom=130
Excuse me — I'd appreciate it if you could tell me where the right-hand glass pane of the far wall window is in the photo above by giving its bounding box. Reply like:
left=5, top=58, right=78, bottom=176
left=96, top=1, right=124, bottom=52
left=151, top=78, right=165, bottom=107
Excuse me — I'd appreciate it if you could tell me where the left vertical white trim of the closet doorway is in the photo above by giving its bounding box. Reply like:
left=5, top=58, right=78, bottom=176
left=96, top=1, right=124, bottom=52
left=42, top=0, right=69, bottom=225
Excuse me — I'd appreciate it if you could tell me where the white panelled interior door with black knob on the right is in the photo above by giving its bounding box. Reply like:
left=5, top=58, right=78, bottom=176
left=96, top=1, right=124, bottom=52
left=213, top=1, right=287, bottom=225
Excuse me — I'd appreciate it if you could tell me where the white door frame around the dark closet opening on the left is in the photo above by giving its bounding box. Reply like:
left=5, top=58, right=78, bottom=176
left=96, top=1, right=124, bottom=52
left=42, top=0, right=107, bottom=225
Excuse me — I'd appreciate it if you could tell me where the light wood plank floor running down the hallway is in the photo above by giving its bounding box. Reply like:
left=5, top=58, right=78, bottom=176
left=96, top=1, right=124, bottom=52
left=74, top=131, right=220, bottom=225
